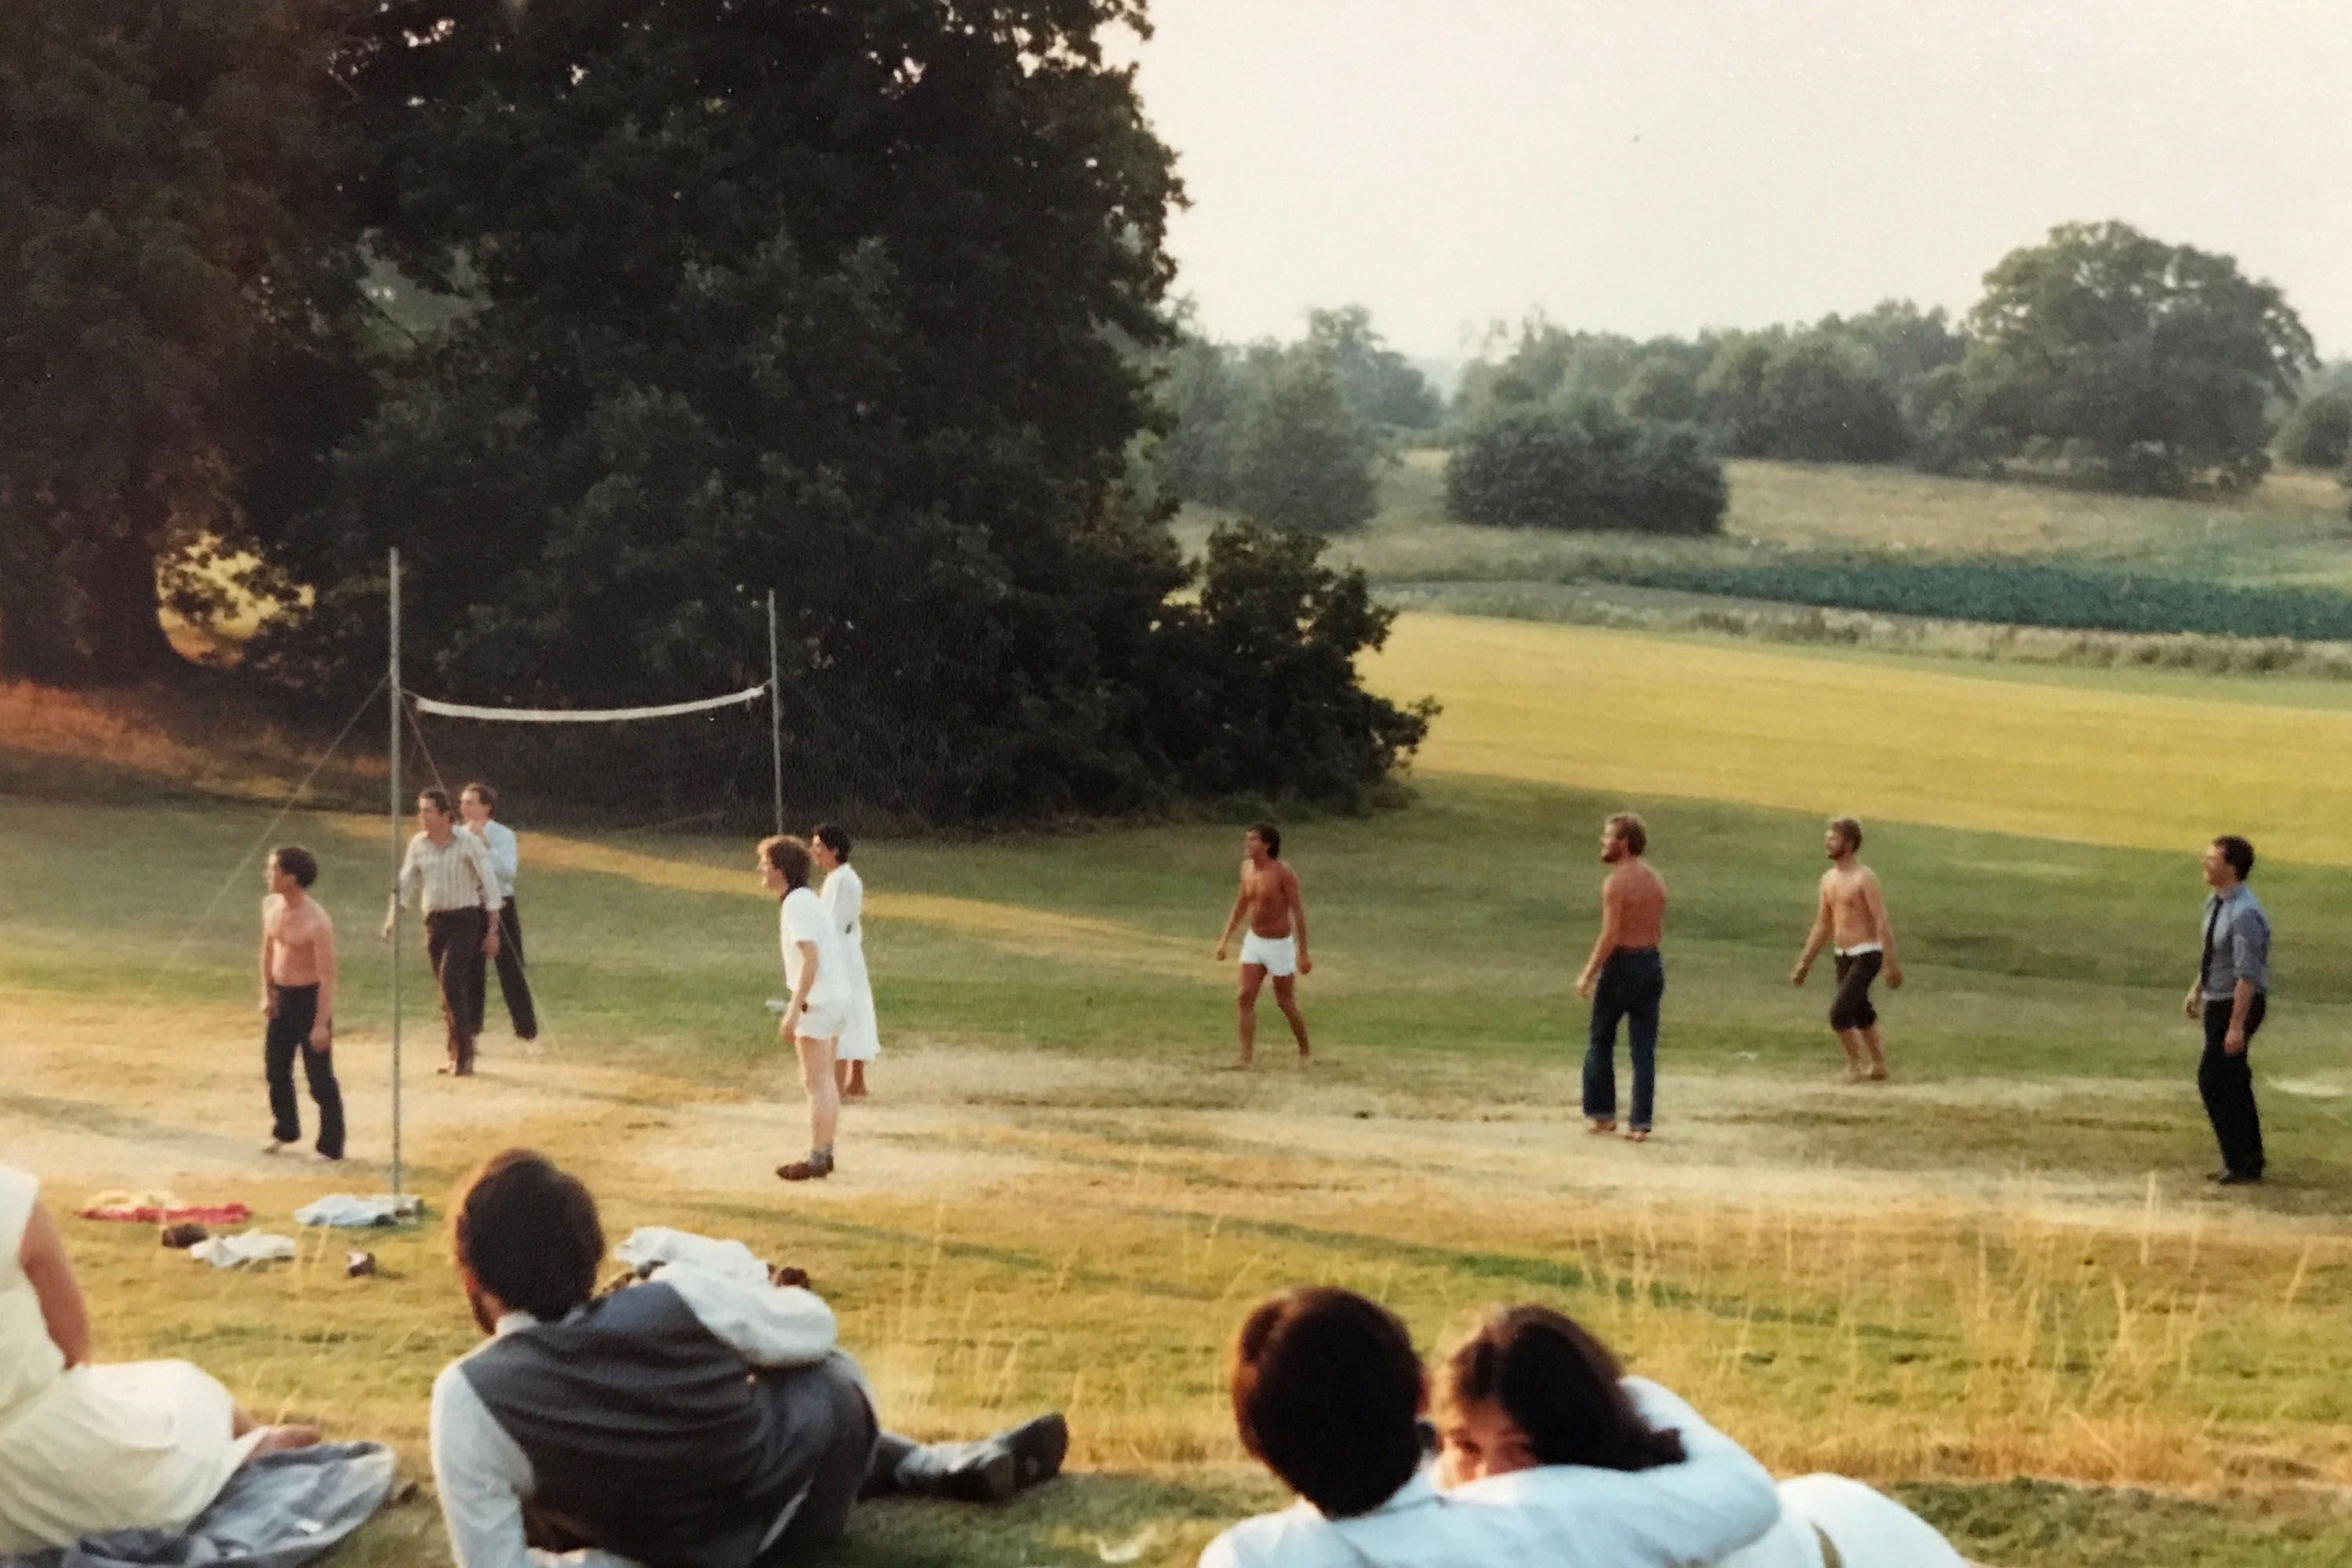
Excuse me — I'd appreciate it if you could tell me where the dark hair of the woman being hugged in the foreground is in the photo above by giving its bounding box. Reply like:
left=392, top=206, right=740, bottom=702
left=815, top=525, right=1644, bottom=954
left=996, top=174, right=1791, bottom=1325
left=1437, top=1307, right=1684, bottom=1469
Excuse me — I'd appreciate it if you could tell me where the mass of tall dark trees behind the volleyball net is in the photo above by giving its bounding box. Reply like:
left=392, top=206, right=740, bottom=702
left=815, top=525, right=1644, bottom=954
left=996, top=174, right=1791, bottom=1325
left=0, top=0, right=1428, bottom=820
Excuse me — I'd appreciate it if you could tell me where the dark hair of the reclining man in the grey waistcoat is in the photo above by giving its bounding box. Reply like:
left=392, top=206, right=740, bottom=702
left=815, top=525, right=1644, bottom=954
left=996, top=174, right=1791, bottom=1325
left=449, top=1149, right=604, bottom=1323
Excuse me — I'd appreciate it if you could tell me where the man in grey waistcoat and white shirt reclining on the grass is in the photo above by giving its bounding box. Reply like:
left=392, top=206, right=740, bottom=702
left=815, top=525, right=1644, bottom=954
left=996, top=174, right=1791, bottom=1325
left=433, top=1149, right=1070, bottom=1568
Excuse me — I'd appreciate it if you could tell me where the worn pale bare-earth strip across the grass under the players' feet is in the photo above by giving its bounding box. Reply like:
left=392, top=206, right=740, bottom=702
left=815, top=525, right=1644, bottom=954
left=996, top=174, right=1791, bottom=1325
left=0, top=996, right=2307, bottom=1227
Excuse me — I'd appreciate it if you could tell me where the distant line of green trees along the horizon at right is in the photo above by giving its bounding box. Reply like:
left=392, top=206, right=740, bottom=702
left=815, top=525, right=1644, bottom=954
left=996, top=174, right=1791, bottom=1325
left=1160, top=223, right=2352, bottom=534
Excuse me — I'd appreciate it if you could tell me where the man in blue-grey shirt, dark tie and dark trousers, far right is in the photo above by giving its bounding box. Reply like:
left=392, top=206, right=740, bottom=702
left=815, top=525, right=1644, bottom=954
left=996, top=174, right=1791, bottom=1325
left=2183, top=832, right=2270, bottom=1187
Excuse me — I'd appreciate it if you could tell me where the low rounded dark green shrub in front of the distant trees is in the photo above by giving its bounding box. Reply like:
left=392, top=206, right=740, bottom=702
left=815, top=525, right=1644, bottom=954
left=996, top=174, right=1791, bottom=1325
left=1446, top=400, right=1729, bottom=534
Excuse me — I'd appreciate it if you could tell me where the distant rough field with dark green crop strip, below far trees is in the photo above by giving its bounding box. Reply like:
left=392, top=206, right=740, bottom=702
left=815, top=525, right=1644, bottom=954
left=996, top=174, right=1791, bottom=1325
left=1178, top=452, right=2352, bottom=680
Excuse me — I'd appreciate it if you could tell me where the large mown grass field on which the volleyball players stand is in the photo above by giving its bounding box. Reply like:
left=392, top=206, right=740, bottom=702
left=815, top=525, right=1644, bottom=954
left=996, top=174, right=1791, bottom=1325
left=0, top=616, right=2352, bottom=1568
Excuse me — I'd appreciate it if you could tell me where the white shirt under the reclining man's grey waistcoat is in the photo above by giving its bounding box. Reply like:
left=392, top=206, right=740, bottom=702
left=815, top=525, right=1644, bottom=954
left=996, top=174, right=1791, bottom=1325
left=433, top=1262, right=835, bottom=1568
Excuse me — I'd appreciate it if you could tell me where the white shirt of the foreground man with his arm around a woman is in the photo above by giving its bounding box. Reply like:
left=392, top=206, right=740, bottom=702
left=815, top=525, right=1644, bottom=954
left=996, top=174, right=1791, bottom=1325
left=1200, top=1377, right=1780, bottom=1568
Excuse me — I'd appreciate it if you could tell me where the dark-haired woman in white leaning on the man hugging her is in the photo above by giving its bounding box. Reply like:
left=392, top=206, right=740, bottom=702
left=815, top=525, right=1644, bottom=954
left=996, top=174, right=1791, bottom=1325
left=1437, top=1307, right=1966, bottom=1568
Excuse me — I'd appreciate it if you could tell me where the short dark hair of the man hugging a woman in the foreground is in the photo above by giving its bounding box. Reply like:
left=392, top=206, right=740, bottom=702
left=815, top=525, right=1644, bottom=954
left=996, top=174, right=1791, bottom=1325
left=1232, top=1286, right=1423, bottom=1519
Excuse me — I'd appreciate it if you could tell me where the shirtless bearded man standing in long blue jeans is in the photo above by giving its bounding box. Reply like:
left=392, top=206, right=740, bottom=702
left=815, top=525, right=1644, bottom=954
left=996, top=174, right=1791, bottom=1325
left=1576, top=811, right=1665, bottom=1142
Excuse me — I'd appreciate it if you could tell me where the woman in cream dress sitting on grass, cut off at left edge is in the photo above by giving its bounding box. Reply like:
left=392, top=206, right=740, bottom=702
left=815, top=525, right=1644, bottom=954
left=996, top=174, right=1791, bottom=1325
left=0, top=1166, right=318, bottom=1556
